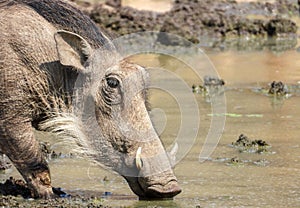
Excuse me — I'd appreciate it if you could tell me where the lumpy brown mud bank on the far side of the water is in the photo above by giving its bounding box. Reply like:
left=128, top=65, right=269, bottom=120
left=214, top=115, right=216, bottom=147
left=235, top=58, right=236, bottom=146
left=82, top=0, right=299, bottom=43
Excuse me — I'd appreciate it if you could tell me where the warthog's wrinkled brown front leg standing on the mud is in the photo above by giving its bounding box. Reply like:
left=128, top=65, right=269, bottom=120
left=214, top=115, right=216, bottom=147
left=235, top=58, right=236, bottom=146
left=0, top=118, right=54, bottom=198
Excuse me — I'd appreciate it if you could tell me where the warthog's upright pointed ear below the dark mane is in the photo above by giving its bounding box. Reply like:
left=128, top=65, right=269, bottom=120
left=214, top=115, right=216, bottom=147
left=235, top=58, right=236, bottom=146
left=54, top=30, right=92, bottom=71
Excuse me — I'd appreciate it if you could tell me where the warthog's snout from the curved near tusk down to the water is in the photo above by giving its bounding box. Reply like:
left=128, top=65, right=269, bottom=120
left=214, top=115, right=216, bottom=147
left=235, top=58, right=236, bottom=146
left=121, top=137, right=181, bottom=199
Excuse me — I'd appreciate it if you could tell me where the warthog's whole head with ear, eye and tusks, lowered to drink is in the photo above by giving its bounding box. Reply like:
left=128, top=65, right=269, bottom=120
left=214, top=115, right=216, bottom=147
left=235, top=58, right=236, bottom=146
left=55, top=31, right=181, bottom=198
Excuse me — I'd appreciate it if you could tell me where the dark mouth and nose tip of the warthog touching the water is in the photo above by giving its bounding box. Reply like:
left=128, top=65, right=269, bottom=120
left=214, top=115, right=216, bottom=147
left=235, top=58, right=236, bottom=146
left=124, top=177, right=181, bottom=200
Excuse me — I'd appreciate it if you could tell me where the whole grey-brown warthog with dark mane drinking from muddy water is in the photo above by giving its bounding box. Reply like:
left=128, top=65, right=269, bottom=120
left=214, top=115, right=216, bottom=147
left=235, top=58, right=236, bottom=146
left=0, top=0, right=181, bottom=198
